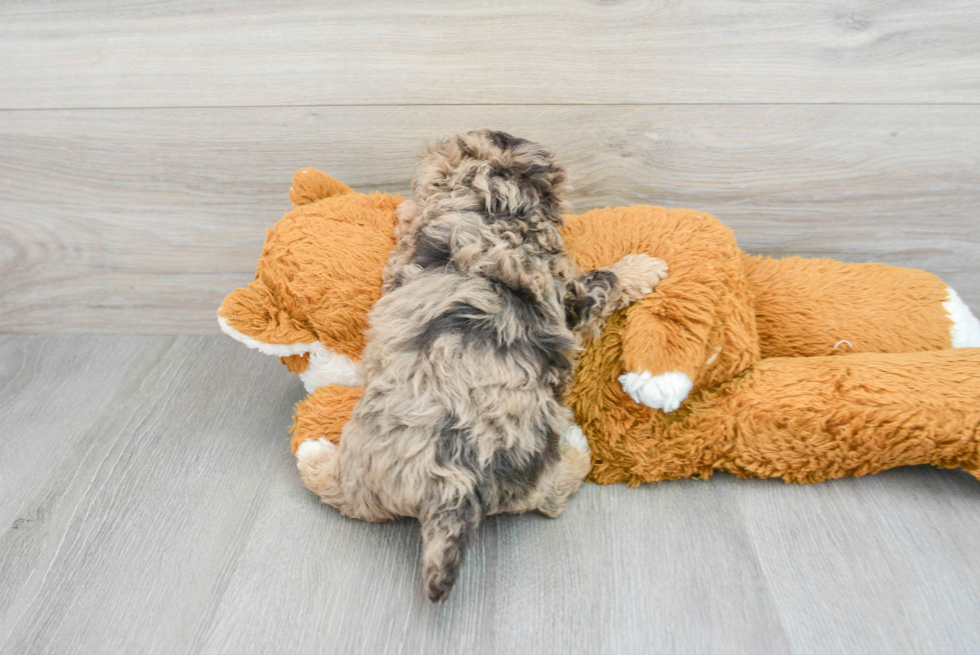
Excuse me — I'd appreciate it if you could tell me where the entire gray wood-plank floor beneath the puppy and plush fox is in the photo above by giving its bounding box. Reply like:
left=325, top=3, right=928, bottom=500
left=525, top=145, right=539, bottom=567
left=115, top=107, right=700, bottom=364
left=0, top=335, right=980, bottom=654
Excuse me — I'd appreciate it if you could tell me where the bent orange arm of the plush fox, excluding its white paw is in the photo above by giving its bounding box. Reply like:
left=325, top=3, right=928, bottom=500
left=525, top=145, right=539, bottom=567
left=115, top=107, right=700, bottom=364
left=563, top=205, right=759, bottom=386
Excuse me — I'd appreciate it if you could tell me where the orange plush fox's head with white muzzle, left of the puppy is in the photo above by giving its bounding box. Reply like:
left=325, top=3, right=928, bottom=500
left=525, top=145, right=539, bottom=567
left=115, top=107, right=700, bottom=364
left=218, top=169, right=403, bottom=391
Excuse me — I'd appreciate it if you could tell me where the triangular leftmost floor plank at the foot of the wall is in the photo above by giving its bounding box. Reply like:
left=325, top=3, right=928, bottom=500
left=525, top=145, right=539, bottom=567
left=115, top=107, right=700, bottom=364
left=0, top=336, right=172, bottom=635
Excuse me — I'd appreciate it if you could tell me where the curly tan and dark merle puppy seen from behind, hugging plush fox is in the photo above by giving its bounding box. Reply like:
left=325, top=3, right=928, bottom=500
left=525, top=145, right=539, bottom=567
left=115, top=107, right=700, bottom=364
left=301, top=130, right=667, bottom=601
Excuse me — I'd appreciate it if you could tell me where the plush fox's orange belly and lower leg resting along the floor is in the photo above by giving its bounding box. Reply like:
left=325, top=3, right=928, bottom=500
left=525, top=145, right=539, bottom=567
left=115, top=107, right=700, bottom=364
left=568, top=316, right=980, bottom=485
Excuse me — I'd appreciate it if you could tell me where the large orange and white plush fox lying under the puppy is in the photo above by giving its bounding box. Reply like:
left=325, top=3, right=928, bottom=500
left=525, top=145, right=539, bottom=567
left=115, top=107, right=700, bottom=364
left=219, top=169, right=980, bottom=484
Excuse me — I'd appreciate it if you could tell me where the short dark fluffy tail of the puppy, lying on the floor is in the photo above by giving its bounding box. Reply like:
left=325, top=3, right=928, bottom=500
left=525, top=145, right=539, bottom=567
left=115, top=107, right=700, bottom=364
left=420, top=497, right=480, bottom=603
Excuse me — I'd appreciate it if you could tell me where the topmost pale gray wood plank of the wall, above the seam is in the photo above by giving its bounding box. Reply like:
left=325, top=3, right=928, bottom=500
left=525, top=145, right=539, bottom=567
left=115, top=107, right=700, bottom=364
left=0, top=0, right=980, bottom=108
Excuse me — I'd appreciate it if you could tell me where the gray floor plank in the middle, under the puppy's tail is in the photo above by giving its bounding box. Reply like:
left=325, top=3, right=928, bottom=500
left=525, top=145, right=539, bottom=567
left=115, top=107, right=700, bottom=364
left=195, top=482, right=789, bottom=653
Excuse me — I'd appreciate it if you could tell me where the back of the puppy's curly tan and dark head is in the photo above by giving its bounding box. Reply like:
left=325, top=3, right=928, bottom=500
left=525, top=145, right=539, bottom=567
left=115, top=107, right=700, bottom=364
left=412, top=130, right=567, bottom=223
